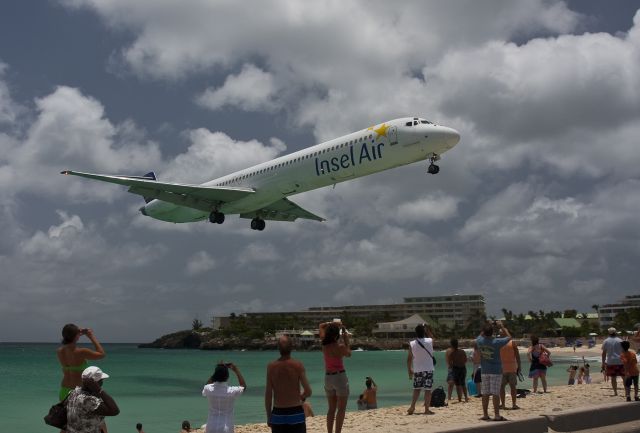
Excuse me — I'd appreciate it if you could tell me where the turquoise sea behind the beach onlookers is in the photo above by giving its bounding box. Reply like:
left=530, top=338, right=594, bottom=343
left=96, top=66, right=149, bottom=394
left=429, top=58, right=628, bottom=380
left=0, top=343, right=595, bottom=433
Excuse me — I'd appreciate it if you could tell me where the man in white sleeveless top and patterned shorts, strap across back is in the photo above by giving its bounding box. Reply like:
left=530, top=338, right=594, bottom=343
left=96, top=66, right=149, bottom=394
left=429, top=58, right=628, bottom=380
left=407, top=324, right=434, bottom=415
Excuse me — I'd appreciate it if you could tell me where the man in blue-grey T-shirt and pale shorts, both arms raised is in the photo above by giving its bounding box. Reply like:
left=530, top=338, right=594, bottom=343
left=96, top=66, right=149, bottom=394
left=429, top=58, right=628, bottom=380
left=476, top=320, right=511, bottom=421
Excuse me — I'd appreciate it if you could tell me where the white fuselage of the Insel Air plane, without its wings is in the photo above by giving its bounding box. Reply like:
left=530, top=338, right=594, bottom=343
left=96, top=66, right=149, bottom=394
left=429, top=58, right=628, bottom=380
left=144, top=117, right=460, bottom=222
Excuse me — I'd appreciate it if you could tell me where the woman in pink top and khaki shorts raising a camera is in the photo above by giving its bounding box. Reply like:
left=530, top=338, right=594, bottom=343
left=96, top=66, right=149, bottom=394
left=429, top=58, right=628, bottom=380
left=320, top=322, right=351, bottom=433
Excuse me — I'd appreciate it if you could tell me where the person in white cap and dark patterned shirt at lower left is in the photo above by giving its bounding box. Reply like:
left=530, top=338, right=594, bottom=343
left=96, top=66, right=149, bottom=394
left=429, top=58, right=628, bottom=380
left=66, top=366, right=120, bottom=433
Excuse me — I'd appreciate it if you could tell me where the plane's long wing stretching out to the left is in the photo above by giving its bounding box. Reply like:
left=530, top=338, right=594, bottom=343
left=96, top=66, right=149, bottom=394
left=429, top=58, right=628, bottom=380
left=61, top=170, right=255, bottom=211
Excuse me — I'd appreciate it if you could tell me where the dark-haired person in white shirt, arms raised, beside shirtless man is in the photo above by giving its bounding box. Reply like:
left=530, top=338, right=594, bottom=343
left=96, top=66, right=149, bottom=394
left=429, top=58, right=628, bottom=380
left=202, top=363, right=247, bottom=433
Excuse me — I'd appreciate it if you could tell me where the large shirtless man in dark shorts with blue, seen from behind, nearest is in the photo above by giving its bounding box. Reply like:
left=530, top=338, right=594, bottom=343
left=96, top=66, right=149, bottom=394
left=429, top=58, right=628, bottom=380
left=264, top=336, right=311, bottom=433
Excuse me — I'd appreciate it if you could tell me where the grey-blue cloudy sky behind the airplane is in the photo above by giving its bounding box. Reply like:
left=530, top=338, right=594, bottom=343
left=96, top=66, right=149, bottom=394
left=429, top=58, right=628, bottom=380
left=0, top=0, right=640, bottom=342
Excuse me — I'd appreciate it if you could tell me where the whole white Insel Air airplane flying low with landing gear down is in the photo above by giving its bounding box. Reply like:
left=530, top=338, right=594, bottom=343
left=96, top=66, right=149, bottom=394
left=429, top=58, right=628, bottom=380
left=61, top=117, right=460, bottom=231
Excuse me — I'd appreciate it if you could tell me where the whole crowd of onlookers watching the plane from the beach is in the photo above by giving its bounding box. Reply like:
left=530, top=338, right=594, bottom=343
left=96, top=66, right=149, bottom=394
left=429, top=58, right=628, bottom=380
left=52, top=319, right=640, bottom=433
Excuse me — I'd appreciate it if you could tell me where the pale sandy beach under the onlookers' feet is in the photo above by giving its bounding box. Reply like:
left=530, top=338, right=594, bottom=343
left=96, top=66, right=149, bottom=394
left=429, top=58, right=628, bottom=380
left=191, top=347, right=624, bottom=433
